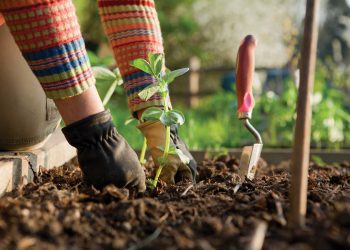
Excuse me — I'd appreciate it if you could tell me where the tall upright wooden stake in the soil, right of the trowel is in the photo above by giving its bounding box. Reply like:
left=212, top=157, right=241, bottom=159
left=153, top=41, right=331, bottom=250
left=289, top=0, right=319, bottom=228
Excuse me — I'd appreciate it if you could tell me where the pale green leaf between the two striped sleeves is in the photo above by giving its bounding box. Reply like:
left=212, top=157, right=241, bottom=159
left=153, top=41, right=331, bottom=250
left=92, top=66, right=123, bottom=106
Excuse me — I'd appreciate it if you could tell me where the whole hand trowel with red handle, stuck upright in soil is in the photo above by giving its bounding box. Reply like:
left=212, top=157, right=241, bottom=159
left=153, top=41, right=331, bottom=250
left=236, top=35, right=263, bottom=180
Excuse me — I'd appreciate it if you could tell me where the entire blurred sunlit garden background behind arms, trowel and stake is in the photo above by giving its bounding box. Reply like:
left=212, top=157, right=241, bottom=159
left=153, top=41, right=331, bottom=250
left=74, top=0, right=350, bottom=149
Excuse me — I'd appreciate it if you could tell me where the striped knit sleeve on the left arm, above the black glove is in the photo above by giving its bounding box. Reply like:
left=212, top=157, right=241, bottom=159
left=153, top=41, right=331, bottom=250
left=0, top=0, right=95, bottom=99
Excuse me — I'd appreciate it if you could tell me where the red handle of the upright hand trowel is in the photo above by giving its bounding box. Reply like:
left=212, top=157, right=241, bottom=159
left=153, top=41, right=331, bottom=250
left=236, top=35, right=257, bottom=119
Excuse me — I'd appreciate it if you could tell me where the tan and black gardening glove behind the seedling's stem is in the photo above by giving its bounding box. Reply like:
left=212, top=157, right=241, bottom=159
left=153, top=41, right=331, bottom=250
left=137, top=121, right=197, bottom=184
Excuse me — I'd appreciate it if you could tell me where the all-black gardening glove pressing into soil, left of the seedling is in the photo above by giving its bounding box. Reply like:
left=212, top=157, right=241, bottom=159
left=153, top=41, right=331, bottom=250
left=62, top=111, right=146, bottom=192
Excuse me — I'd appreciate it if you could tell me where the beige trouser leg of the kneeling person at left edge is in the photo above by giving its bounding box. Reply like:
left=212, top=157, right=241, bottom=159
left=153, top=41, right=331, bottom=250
left=0, top=25, right=60, bottom=150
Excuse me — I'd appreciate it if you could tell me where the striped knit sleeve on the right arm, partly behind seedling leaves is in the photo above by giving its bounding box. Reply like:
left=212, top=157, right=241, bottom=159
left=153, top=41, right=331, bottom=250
left=98, top=0, right=164, bottom=112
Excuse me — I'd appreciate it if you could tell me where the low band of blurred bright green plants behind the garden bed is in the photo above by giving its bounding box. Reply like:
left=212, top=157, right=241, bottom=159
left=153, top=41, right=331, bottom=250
left=97, top=64, right=350, bottom=150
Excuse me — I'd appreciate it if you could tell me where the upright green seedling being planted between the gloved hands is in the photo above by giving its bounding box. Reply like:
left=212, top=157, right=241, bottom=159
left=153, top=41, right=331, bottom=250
left=131, top=53, right=189, bottom=189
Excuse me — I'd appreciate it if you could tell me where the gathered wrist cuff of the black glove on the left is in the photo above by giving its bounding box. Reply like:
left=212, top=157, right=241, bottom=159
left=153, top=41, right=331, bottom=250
left=62, top=110, right=116, bottom=147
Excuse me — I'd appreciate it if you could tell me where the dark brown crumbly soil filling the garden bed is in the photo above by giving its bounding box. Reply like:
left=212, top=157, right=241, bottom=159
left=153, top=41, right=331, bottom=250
left=0, top=156, right=350, bottom=250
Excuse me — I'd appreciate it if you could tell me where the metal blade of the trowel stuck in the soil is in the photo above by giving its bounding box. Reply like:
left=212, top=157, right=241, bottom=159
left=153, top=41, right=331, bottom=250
left=239, top=143, right=263, bottom=181
